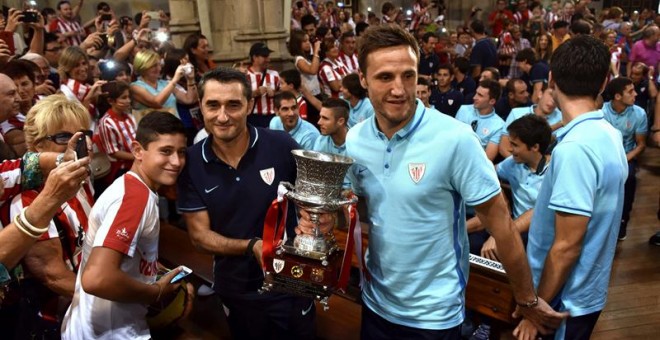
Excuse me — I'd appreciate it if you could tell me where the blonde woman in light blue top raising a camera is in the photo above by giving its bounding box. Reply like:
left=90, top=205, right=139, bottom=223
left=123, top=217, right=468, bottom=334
left=131, top=50, right=197, bottom=120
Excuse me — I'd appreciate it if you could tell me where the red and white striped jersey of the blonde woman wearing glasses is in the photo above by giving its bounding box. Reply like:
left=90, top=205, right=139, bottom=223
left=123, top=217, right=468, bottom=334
left=2, top=182, right=94, bottom=271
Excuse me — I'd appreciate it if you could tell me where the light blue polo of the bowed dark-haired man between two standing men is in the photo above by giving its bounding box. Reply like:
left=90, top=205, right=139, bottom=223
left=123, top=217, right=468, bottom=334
left=495, top=156, right=549, bottom=218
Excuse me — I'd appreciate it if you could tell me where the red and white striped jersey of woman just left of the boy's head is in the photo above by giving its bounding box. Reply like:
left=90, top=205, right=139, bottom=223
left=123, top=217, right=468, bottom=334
left=97, top=109, right=137, bottom=161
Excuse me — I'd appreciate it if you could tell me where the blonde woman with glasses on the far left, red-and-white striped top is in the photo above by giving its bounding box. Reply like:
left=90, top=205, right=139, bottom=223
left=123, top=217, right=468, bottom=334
left=9, top=94, right=94, bottom=338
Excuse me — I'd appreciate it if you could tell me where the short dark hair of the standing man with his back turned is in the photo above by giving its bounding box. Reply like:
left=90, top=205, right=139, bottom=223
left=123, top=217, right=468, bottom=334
left=550, top=35, right=610, bottom=99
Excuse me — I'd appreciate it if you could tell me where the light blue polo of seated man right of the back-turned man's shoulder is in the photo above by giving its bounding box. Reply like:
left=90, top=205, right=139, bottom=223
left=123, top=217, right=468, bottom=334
left=603, top=102, right=648, bottom=153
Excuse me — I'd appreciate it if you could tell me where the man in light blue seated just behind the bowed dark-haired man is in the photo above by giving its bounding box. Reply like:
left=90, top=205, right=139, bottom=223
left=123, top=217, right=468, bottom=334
left=500, top=84, right=563, bottom=158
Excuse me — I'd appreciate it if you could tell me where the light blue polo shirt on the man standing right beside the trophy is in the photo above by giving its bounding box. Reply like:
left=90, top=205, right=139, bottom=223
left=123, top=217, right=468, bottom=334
left=346, top=100, right=500, bottom=329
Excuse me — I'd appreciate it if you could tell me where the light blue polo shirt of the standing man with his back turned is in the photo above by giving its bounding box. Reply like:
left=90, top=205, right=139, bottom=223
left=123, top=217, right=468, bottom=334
left=527, top=110, right=628, bottom=326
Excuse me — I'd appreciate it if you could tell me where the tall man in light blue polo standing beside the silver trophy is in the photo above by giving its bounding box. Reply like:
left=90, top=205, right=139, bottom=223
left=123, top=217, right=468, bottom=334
left=299, top=25, right=563, bottom=339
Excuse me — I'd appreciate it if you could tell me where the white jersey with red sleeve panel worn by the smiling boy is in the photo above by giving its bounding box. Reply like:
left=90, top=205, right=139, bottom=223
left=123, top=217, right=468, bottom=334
left=62, top=172, right=160, bottom=339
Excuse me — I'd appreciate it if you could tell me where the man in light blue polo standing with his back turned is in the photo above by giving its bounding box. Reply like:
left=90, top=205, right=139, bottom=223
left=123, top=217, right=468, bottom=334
left=520, top=35, right=628, bottom=339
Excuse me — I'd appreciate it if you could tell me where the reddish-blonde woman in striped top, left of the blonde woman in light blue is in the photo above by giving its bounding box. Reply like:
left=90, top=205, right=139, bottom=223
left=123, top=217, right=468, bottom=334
left=57, top=46, right=105, bottom=114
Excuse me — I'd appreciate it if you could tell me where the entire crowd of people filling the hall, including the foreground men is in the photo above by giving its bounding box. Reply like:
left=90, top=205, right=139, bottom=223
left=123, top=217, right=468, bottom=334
left=0, top=0, right=660, bottom=340
